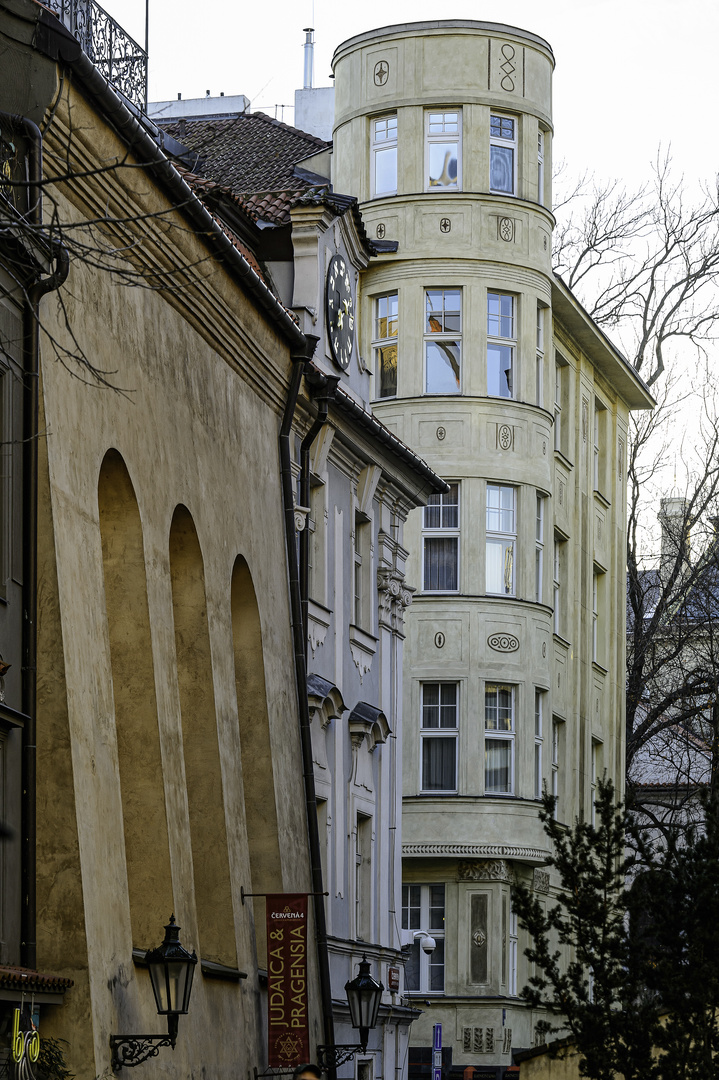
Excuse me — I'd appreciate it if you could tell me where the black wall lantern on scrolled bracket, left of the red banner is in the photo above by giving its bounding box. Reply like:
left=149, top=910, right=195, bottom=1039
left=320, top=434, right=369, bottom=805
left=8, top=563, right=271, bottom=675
left=110, top=915, right=198, bottom=1070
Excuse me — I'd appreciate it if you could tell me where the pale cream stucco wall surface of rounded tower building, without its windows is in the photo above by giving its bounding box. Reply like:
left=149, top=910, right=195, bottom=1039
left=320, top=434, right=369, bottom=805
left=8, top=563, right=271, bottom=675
left=333, top=21, right=647, bottom=1067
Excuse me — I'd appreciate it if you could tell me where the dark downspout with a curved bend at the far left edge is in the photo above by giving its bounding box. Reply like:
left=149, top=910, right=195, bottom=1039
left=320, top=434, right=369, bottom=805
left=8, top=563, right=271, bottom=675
left=0, top=111, right=70, bottom=968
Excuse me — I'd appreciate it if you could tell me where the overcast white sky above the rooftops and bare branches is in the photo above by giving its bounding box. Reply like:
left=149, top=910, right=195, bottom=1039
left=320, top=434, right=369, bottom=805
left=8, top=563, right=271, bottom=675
left=104, top=0, right=719, bottom=192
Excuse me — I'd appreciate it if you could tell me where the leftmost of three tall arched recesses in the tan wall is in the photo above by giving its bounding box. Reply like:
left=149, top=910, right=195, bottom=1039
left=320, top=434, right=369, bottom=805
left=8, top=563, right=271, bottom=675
left=97, top=450, right=175, bottom=948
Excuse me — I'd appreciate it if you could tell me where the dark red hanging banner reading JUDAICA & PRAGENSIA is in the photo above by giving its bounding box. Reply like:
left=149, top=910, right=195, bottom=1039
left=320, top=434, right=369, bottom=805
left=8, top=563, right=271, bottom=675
left=266, top=892, right=310, bottom=1069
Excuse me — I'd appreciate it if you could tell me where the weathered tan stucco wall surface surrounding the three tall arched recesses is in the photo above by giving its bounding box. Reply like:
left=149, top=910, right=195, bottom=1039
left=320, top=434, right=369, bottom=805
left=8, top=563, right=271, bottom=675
left=32, top=79, right=318, bottom=1080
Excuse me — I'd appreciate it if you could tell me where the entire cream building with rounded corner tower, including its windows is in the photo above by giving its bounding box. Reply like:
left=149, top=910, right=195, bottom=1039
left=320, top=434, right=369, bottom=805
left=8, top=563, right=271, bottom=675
left=333, top=21, right=652, bottom=1080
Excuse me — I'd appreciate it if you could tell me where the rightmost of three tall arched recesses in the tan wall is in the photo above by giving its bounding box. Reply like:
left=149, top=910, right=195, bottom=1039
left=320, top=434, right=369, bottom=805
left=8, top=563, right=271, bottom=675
left=232, top=555, right=283, bottom=966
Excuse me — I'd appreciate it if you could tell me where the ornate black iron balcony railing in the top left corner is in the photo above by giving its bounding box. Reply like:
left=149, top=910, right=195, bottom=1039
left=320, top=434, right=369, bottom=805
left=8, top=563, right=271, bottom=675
left=43, top=0, right=147, bottom=109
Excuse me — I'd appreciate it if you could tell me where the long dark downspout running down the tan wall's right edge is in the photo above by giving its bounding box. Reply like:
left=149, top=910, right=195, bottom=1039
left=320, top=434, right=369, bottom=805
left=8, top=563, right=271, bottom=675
left=280, top=334, right=336, bottom=1080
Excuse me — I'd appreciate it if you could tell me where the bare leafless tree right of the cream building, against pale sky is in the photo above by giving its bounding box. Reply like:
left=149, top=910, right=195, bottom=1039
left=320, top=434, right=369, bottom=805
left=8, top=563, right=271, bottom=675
left=554, top=154, right=719, bottom=827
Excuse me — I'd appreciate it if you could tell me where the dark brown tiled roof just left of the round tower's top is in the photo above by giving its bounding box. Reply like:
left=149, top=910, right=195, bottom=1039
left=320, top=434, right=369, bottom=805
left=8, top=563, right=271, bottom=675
left=155, top=112, right=331, bottom=194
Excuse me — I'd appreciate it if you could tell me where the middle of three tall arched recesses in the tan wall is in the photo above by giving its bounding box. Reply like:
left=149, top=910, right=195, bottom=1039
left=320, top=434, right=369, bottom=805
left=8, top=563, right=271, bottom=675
left=169, top=505, right=236, bottom=967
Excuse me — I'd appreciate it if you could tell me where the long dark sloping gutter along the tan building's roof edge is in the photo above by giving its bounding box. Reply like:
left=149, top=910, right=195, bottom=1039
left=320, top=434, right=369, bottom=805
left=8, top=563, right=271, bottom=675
left=29, top=8, right=306, bottom=350
